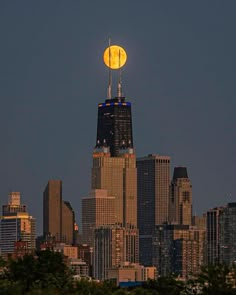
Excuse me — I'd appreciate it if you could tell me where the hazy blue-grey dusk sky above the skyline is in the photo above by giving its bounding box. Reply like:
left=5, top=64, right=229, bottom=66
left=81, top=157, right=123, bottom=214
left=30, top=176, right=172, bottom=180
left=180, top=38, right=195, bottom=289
left=0, top=0, right=236, bottom=233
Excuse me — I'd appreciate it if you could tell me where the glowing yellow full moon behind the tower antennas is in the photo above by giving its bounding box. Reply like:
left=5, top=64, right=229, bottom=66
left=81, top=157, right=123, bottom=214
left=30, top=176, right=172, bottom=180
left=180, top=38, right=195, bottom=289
left=103, top=45, right=127, bottom=70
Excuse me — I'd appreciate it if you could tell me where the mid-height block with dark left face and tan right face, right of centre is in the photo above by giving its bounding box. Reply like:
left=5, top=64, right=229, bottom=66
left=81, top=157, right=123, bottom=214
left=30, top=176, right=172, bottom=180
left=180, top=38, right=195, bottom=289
left=153, top=224, right=205, bottom=279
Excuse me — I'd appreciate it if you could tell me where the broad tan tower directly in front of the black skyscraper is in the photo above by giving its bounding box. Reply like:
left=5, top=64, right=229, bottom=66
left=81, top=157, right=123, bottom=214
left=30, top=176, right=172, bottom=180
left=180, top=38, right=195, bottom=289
left=92, top=147, right=137, bottom=226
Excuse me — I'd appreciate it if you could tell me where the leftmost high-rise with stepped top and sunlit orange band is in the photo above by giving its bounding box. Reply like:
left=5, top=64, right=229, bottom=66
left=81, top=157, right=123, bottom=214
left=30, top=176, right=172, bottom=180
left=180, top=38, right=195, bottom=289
left=0, top=192, right=36, bottom=255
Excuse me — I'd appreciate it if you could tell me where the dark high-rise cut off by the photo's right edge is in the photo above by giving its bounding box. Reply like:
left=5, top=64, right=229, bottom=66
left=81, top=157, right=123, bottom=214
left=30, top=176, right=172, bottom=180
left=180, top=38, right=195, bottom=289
left=219, top=203, right=236, bottom=265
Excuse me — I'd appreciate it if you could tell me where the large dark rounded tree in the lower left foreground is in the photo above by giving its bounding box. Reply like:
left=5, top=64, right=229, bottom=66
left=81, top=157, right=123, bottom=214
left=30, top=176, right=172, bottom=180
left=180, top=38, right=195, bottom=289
left=3, top=250, right=73, bottom=294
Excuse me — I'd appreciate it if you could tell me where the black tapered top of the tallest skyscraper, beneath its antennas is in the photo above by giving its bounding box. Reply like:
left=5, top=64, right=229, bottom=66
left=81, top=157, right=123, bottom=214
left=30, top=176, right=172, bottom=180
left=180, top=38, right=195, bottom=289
left=97, top=97, right=133, bottom=157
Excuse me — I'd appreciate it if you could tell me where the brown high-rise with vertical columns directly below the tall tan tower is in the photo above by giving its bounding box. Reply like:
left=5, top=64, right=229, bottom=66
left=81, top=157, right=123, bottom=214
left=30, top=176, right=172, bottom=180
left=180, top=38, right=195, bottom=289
left=94, top=225, right=139, bottom=280
